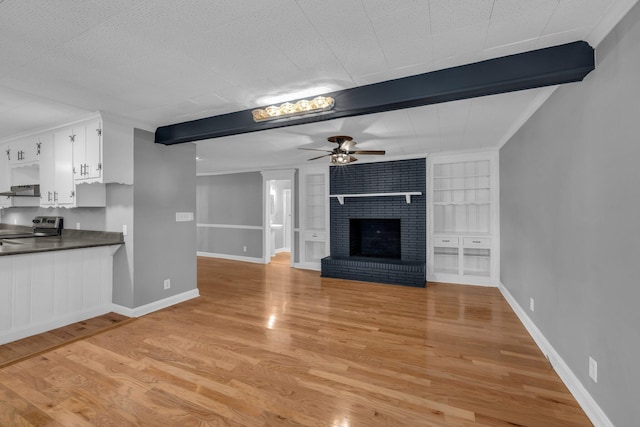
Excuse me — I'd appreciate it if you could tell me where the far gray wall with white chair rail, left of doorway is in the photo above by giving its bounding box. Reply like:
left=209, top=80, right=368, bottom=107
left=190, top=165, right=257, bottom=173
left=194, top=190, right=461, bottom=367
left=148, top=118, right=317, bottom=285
left=196, top=172, right=263, bottom=258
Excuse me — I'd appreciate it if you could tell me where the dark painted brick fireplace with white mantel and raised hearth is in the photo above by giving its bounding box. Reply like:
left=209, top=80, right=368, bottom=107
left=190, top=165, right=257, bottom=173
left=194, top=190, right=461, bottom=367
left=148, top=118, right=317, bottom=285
left=322, top=159, right=427, bottom=287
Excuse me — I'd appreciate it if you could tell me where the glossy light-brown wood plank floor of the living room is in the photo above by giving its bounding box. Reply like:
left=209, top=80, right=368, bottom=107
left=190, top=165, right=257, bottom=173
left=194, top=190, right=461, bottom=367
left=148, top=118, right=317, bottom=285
left=0, top=258, right=591, bottom=427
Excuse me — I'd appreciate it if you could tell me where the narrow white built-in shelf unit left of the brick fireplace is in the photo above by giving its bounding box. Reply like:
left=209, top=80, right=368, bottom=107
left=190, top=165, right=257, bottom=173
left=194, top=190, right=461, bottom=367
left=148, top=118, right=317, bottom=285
left=298, top=166, right=329, bottom=270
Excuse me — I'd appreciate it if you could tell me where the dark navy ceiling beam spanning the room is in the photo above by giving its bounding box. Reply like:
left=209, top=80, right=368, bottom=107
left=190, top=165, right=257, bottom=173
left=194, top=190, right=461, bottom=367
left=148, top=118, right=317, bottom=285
left=155, top=41, right=595, bottom=145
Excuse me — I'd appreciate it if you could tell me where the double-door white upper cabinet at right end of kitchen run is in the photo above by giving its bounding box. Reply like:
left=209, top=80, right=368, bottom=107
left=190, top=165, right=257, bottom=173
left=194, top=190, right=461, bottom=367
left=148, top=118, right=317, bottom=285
left=69, top=119, right=102, bottom=183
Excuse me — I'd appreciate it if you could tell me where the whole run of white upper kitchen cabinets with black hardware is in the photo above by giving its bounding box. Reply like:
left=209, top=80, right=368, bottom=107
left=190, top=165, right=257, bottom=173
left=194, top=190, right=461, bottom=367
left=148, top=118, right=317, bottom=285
left=0, top=114, right=133, bottom=207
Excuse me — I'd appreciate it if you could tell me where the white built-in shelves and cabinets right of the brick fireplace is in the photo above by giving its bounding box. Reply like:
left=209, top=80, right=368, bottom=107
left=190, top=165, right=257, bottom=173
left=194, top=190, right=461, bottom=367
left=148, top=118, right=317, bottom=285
left=427, top=151, right=499, bottom=285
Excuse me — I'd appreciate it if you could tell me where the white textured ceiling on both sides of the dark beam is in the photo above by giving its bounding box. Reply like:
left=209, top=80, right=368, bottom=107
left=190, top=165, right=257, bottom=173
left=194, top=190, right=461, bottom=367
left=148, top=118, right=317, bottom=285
left=0, top=0, right=636, bottom=173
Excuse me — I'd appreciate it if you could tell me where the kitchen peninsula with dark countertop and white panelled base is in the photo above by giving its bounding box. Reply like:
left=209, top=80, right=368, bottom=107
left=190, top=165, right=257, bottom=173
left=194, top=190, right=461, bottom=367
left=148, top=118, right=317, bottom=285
left=0, top=224, right=124, bottom=344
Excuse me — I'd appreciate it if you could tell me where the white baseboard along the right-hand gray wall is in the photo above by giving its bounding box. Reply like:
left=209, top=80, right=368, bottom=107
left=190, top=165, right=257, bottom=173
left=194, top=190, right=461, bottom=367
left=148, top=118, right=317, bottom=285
left=498, top=283, right=614, bottom=427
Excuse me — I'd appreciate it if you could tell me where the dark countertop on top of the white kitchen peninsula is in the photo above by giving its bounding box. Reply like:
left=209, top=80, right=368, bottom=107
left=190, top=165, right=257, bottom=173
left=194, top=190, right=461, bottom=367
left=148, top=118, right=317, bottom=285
left=0, top=224, right=124, bottom=256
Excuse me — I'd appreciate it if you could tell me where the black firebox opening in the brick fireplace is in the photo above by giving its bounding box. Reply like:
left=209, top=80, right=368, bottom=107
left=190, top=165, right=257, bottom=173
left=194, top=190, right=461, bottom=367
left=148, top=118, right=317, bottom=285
left=349, top=218, right=402, bottom=259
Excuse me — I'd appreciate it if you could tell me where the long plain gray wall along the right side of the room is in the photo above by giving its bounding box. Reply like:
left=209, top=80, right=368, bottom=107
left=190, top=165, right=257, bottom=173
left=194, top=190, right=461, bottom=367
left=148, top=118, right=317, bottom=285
left=500, top=5, right=640, bottom=426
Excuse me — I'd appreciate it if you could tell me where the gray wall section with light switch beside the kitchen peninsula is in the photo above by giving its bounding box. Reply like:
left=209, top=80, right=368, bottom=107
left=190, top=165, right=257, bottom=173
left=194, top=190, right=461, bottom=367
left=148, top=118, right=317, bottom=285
left=133, top=129, right=197, bottom=307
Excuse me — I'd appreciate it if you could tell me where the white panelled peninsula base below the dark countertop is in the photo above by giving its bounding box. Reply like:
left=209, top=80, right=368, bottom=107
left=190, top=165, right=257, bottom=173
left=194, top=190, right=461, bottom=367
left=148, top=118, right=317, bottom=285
left=0, top=246, right=115, bottom=345
